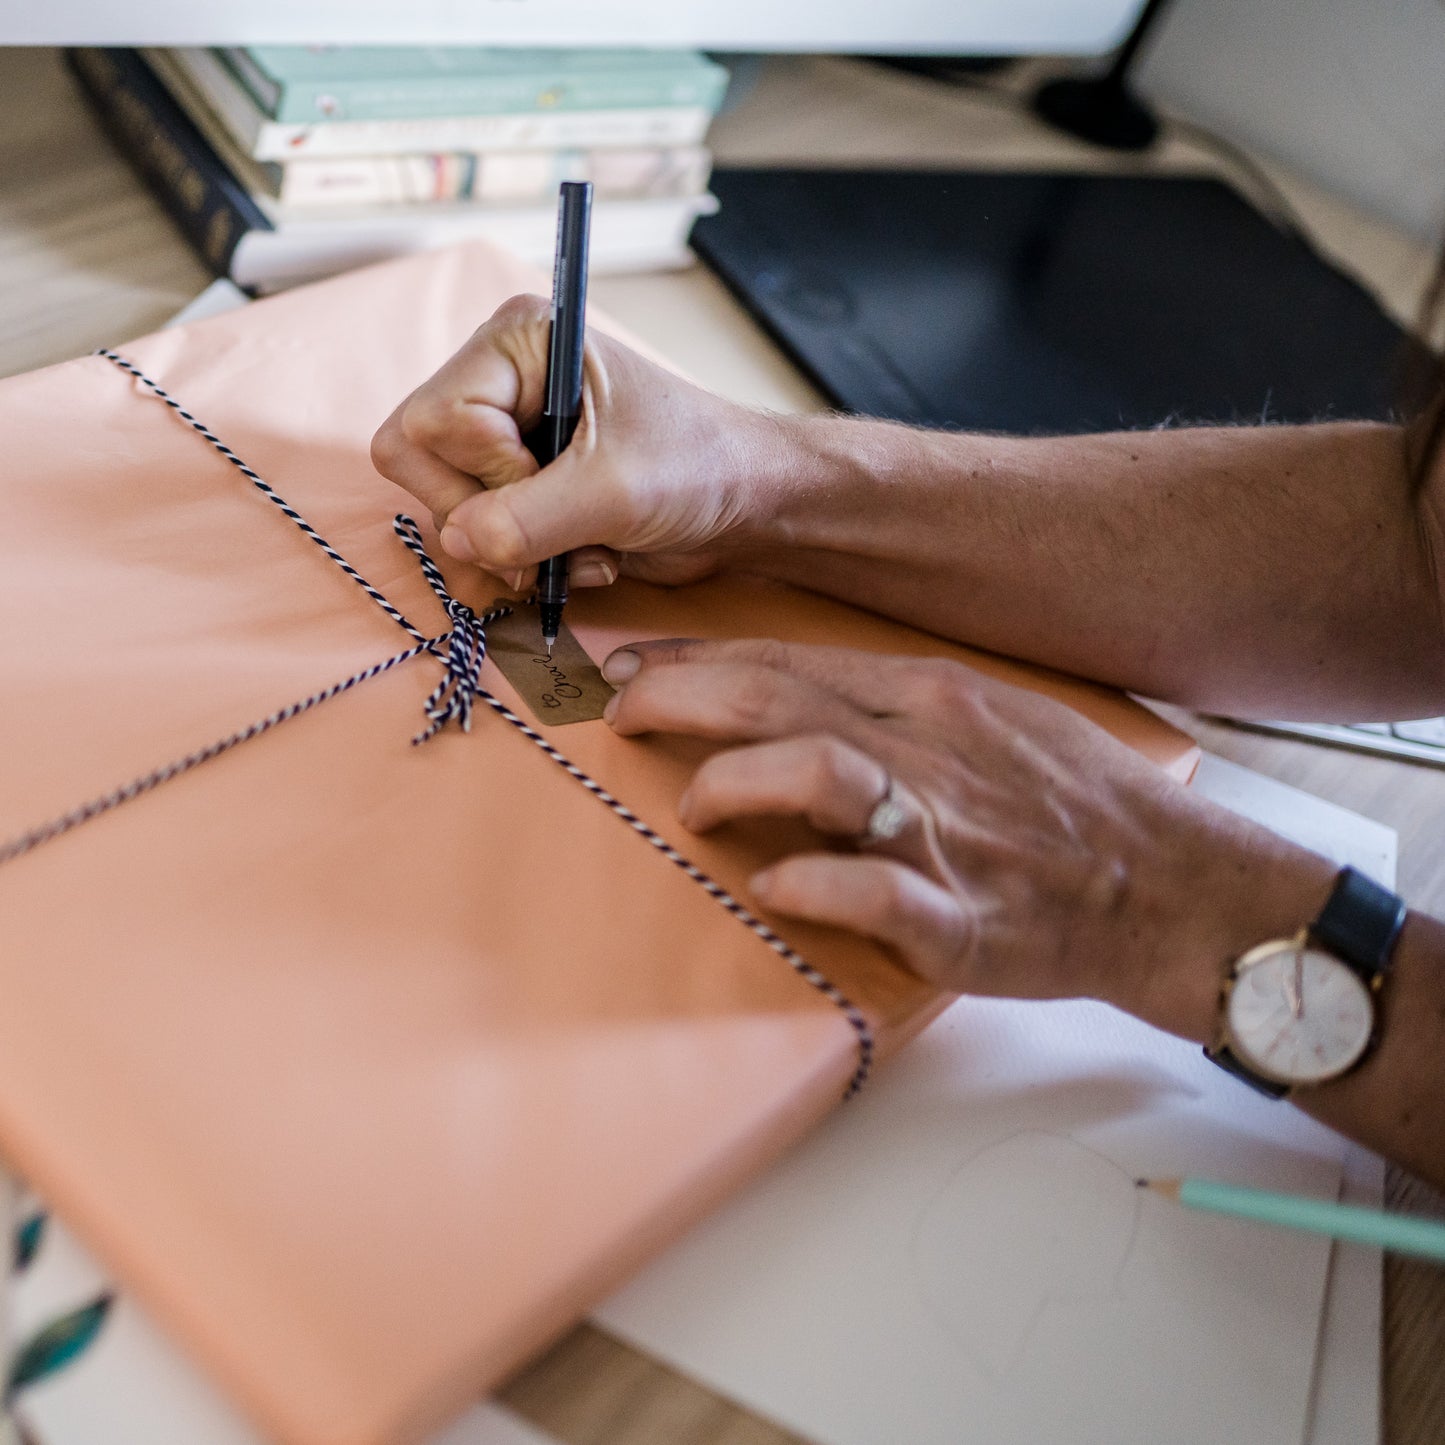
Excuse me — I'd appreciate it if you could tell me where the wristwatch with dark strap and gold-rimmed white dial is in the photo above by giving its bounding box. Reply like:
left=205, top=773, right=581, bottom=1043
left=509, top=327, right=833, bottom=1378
left=1204, top=868, right=1406, bottom=1098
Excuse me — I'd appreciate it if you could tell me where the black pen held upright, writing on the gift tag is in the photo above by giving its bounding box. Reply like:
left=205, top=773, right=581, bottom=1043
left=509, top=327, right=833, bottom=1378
left=527, top=181, right=592, bottom=657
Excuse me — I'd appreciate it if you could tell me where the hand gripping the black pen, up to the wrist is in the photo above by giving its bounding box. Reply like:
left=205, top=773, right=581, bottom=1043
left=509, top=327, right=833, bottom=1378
left=371, top=296, right=786, bottom=591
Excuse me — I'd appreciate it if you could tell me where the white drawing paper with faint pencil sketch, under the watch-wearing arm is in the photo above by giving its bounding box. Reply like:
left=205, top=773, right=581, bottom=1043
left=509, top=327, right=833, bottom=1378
left=595, top=759, right=1394, bottom=1445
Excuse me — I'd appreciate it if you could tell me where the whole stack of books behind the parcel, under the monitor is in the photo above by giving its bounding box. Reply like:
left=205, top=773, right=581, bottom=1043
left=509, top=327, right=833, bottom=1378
left=66, top=46, right=727, bottom=292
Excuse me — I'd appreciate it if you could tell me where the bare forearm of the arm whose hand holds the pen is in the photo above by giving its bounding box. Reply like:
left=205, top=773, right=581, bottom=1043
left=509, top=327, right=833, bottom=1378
left=734, top=418, right=1445, bottom=720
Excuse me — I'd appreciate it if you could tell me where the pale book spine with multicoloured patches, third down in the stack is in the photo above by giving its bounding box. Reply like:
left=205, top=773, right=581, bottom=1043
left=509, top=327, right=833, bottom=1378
left=276, top=146, right=712, bottom=210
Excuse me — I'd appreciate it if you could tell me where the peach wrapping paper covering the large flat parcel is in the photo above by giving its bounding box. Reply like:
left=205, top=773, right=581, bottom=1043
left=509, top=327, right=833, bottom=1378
left=0, top=246, right=1195, bottom=1445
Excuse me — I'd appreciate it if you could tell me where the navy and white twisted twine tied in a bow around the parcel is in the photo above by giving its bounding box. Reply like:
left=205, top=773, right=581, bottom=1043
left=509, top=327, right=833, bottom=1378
left=0, top=348, right=873, bottom=1097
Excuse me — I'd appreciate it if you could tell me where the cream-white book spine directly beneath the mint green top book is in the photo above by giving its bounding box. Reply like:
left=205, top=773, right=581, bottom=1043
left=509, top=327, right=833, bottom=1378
left=257, top=105, right=711, bottom=160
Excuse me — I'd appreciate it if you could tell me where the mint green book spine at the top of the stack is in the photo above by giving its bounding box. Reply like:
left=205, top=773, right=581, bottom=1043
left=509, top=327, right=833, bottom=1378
left=247, top=58, right=727, bottom=126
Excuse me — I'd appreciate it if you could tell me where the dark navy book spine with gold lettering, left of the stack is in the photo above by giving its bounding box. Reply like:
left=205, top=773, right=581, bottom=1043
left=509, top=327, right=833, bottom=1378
left=65, top=48, right=270, bottom=276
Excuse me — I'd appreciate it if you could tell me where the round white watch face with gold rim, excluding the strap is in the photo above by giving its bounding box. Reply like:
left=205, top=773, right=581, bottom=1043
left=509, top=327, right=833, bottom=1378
left=1225, top=944, right=1374, bottom=1084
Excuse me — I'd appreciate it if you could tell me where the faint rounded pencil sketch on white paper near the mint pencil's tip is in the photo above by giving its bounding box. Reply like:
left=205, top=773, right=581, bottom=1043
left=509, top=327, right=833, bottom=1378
left=909, top=1130, right=1139, bottom=1381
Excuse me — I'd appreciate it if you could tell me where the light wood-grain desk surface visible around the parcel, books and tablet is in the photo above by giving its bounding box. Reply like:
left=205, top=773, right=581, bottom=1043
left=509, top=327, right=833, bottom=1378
left=0, top=49, right=1445, bottom=1445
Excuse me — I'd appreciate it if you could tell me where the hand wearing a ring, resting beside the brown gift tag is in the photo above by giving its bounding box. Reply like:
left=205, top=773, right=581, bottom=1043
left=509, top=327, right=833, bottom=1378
left=603, top=642, right=1332, bottom=1039
